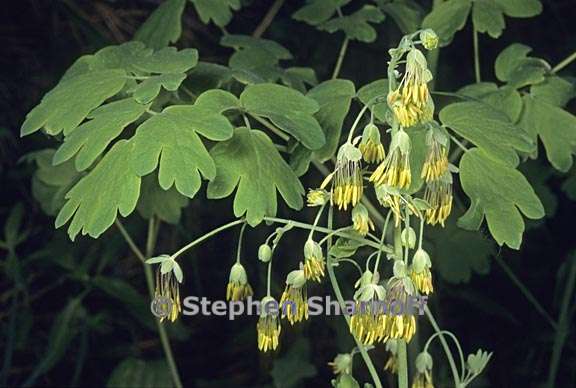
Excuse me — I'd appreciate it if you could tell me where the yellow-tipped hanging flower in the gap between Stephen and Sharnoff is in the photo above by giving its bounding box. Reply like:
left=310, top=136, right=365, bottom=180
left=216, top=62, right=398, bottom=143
left=280, top=269, right=308, bottom=325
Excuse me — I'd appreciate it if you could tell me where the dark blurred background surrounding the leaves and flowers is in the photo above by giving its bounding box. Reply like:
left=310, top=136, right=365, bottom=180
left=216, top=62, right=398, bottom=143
left=0, top=0, right=576, bottom=387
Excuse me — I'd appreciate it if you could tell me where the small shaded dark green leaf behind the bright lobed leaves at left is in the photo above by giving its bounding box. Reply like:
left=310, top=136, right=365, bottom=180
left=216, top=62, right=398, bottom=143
left=137, top=174, right=188, bottom=224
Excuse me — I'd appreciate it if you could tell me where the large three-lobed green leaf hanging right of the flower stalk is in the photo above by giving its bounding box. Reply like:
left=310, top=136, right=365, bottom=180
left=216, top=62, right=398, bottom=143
left=458, top=148, right=545, bottom=249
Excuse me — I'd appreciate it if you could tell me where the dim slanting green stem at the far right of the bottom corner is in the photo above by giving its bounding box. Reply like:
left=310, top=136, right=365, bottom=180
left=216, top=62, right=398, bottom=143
left=547, top=259, right=576, bottom=388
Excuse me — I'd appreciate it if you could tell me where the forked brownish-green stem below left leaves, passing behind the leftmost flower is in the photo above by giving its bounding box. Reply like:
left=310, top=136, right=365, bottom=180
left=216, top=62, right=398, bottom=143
left=115, top=218, right=182, bottom=388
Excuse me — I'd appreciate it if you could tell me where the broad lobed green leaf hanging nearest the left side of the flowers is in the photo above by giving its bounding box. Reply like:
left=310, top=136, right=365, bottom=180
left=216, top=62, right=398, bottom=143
left=208, top=128, right=304, bottom=226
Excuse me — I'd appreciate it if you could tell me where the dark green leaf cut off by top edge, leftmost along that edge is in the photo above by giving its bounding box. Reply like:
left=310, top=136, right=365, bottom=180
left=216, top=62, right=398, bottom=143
left=134, top=0, right=186, bottom=49
